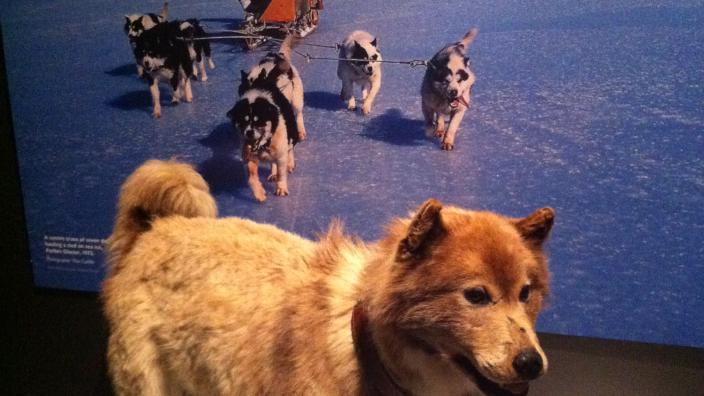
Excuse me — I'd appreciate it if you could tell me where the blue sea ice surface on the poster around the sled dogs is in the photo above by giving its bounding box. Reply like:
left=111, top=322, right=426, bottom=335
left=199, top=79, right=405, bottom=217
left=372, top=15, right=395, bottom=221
left=2, top=0, right=704, bottom=347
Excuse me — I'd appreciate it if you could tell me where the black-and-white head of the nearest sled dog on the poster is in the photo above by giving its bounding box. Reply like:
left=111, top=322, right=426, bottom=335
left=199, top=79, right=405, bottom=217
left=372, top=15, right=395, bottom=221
left=227, top=88, right=280, bottom=152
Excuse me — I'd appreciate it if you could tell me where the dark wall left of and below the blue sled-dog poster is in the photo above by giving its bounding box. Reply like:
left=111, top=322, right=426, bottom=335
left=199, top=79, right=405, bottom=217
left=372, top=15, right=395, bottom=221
left=0, top=27, right=704, bottom=396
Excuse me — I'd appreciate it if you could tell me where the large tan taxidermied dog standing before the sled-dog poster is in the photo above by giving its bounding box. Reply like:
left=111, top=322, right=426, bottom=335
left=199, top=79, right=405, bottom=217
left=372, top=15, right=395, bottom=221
left=102, top=161, right=554, bottom=395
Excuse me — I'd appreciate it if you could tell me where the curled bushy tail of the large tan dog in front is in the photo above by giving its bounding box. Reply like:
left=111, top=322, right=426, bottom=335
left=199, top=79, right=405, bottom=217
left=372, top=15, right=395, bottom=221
left=106, top=160, right=217, bottom=273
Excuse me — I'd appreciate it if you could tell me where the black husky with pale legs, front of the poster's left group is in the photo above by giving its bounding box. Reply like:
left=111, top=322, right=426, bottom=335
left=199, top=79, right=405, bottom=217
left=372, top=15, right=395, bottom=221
left=134, top=21, right=193, bottom=118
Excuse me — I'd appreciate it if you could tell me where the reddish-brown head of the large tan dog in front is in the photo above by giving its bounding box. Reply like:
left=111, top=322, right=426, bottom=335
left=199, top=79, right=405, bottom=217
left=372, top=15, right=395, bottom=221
left=369, top=200, right=555, bottom=393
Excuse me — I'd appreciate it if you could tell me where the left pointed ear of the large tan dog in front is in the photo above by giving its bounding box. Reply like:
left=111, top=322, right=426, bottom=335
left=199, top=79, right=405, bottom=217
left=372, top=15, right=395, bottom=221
left=397, top=198, right=445, bottom=261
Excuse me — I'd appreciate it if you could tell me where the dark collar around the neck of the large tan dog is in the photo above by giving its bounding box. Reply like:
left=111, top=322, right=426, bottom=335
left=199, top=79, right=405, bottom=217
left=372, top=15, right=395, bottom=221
left=351, top=301, right=411, bottom=396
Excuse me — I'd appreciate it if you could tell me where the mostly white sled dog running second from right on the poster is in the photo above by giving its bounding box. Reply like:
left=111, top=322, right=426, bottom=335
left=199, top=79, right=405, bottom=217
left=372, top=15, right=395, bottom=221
left=337, top=30, right=382, bottom=115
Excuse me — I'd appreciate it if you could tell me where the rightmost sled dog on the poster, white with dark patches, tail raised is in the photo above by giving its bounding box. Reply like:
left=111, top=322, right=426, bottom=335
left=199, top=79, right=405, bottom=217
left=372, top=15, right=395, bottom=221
left=420, top=28, right=479, bottom=150
